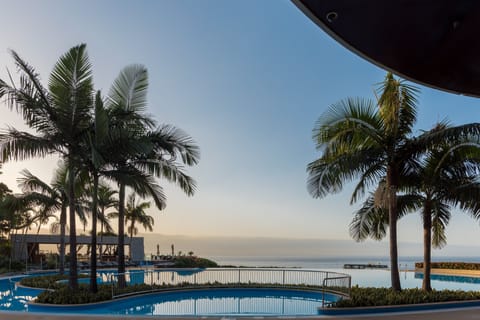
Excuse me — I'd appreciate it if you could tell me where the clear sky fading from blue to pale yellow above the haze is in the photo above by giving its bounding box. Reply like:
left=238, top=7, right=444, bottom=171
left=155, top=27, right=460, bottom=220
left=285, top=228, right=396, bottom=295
left=0, top=0, right=480, bottom=254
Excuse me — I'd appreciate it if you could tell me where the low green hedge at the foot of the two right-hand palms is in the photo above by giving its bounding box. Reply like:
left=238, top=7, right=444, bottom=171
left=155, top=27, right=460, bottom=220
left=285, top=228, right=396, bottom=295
left=332, top=286, right=480, bottom=308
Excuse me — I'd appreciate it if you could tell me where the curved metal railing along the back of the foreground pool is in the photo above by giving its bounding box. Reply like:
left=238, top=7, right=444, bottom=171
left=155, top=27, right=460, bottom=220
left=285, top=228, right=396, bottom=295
left=107, top=268, right=351, bottom=299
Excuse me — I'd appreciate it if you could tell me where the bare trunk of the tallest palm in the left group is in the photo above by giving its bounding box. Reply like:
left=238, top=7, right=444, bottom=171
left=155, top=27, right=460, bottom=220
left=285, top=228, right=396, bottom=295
left=68, top=164, right=78, bottom=291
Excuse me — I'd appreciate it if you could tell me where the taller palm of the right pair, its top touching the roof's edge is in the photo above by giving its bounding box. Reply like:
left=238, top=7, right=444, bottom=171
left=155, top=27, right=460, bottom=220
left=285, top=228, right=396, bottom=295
left=307, top=73, right=418, bottom=291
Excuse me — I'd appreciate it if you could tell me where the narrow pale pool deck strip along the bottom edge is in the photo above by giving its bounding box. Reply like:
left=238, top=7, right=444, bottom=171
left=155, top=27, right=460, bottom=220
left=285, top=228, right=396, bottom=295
left=0, top=308, right=480, bottom=320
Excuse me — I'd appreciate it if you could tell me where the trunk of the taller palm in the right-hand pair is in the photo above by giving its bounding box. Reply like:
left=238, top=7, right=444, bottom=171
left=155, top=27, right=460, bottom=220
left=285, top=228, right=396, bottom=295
left=386, top=165, right=402, bottom=291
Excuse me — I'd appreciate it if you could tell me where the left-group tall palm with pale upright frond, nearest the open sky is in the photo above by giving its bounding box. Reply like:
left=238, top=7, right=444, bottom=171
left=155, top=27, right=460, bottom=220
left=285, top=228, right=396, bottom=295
left=103, top=65, right=199, bottom=287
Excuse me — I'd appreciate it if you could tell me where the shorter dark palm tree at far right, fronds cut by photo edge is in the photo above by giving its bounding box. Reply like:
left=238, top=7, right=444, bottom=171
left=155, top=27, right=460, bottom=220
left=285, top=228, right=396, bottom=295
left=407, top=132, right=480, bottom=291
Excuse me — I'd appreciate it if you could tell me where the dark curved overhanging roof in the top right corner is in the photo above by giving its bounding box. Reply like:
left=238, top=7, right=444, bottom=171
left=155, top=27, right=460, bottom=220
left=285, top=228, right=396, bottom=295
left=292, top=0, right=480, bottom=97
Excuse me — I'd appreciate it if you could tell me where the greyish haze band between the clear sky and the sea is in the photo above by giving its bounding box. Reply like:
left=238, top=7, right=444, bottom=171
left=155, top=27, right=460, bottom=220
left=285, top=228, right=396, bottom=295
left=140, top=234, right=478, bottom=258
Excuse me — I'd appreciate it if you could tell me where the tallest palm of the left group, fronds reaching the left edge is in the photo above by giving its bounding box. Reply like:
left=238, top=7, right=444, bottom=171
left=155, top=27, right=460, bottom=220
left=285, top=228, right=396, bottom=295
left=0, top=44, right=93, bottom=290
